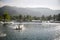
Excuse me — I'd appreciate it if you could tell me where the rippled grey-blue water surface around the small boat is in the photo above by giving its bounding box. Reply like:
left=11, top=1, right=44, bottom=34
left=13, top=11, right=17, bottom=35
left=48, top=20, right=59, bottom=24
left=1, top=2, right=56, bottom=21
left=0, top=22, right=60, bottom=40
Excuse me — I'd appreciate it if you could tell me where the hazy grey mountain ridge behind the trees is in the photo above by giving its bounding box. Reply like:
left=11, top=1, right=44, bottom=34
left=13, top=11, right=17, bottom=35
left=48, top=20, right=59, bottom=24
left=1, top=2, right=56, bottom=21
left=0, top=6, right=60, bottom=17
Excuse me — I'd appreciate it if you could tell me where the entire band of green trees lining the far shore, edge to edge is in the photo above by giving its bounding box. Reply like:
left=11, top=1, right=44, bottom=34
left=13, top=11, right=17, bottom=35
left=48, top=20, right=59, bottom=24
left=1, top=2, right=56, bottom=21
left=0, top=11, right=60, bottom=22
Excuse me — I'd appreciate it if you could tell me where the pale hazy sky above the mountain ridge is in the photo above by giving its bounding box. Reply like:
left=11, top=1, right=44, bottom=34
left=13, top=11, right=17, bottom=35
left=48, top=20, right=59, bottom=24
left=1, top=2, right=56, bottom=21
left=0, top=0, right=60, bottom=10
